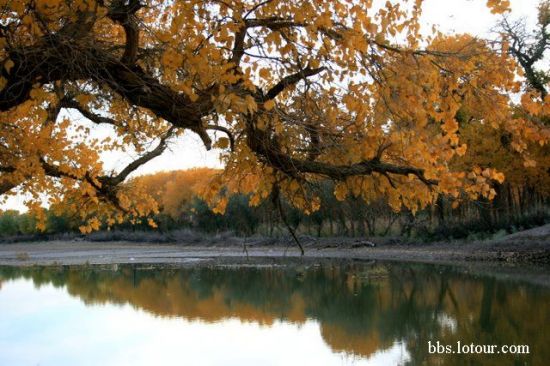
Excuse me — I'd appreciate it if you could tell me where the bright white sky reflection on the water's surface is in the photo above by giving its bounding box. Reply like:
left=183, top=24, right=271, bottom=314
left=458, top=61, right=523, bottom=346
left=0, top=280, right=409, bottom=366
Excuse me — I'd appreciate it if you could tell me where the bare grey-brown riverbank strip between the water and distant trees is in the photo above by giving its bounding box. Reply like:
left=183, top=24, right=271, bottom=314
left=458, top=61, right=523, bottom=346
left=0, top=225, right=550, bottom=266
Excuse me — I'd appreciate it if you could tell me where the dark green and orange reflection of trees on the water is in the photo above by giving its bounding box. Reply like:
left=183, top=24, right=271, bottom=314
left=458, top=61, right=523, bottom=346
left=0, top=264, right=550, bottom=365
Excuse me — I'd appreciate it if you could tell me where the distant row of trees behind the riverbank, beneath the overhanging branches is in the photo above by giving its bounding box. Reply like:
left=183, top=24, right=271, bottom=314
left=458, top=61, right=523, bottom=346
left=0, top=168, right=550, bottom=240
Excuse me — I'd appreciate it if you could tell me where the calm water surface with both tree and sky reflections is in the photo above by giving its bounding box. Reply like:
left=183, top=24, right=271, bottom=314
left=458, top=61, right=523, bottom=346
left=0, top=263, right=550, bottom=365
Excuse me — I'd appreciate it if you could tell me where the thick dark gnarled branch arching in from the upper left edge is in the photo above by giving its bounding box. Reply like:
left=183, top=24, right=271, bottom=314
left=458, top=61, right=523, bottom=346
left=0, top=36, right=212, bottom=149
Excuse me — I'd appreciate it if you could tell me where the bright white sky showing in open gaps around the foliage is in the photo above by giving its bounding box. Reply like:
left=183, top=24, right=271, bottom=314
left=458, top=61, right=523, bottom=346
left=0, top=0, right=539, bottom=211
